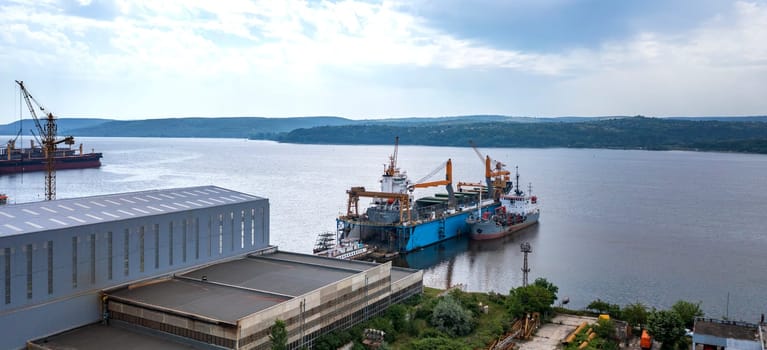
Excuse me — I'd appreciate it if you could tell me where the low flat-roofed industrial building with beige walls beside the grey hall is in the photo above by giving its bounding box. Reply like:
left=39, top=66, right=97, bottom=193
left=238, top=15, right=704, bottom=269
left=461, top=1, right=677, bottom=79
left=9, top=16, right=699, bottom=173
left=34, top=250, right=423, bottom=349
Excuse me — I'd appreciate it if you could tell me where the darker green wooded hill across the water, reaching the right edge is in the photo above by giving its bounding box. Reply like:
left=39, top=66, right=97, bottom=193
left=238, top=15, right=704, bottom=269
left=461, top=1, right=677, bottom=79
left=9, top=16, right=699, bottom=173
left=278, top=117, right=767, bottom=153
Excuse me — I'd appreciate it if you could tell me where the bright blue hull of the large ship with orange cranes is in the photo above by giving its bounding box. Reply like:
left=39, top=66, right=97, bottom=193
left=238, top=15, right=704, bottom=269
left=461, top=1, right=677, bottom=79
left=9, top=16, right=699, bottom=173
left=338, top=205, right=497, bottom=253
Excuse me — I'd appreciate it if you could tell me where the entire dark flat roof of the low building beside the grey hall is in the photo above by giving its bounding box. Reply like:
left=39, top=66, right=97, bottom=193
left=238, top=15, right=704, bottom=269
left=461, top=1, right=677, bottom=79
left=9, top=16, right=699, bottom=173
left=107, top=252, right=417, bottom=324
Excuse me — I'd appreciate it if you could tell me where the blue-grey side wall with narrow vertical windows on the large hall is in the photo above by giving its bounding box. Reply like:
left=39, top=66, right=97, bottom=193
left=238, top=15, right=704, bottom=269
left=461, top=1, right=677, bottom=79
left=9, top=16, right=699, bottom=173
left=0, top=199, right=269, bottom=349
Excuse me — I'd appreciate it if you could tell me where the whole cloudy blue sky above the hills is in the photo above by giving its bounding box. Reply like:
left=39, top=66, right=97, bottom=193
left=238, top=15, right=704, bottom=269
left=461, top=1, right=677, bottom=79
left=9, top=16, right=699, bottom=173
left=0, top=0, right=767, bottom=124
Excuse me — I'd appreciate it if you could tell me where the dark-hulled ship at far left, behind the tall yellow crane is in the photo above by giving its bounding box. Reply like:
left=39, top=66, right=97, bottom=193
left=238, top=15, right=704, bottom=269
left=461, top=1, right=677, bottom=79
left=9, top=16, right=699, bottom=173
left=0, top=140, right=102, bottom=175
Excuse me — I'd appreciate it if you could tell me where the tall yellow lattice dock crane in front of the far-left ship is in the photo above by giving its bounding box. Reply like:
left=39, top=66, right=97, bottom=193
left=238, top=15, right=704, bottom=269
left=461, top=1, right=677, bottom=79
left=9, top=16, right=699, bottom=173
left=16, top=80, right=75, bottom=200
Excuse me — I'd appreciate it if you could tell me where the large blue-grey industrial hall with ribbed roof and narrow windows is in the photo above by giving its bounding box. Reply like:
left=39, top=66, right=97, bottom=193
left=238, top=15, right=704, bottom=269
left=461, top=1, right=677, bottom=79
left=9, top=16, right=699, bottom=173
left=0, top=186, right=269, bottom=349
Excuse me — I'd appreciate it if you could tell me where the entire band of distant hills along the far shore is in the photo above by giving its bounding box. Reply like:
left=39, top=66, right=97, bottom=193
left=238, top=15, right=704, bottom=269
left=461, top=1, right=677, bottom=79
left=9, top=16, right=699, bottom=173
left=0, top=115, right=767, bottom=153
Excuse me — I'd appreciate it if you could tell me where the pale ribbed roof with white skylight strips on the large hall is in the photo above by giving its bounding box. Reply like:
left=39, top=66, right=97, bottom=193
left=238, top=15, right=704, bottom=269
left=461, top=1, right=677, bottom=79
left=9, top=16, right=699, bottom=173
left=0, top=186, right=264, bottom=237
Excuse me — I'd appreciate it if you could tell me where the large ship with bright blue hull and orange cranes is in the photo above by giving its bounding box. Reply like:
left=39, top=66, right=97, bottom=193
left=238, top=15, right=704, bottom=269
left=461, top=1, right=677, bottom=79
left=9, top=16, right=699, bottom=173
left=336, top=139, right=499, bottom=256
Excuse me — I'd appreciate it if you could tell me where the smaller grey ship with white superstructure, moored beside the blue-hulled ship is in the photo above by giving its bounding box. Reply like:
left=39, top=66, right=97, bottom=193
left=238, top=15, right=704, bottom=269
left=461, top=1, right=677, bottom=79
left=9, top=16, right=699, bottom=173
left=466, top=169, right=541, bottom=240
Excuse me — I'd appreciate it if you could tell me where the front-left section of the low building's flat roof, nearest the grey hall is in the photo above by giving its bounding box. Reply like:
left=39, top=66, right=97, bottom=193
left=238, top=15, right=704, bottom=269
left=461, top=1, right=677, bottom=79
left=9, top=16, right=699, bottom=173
left=109, top=278, right=290, bottom=325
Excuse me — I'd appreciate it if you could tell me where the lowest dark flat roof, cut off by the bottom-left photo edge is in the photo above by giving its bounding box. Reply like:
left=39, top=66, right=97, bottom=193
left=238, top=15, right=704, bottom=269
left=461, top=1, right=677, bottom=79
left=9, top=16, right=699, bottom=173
left=33, top=324, right=197, bottom=350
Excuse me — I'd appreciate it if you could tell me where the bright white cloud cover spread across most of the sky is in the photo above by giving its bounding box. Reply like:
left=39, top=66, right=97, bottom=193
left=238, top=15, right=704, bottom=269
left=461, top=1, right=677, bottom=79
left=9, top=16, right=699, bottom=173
left=0, top=0, right=767, bottom=116
